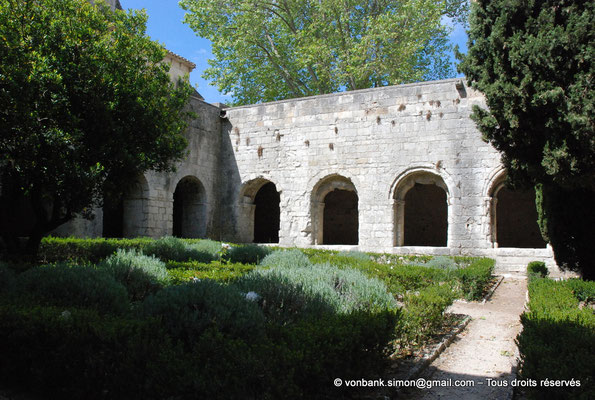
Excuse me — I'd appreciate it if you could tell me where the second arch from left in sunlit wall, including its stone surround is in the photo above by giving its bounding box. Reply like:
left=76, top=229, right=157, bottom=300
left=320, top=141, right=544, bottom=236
left=311, top=174, right=359, bottom=245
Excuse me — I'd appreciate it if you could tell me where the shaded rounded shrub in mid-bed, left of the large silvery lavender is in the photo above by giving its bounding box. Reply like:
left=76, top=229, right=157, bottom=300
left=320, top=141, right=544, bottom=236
left=141, top=280, right=264, bottom=344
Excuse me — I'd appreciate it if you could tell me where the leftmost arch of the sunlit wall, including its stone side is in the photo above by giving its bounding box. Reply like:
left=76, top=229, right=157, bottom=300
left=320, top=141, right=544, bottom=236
left=240, top=177, right=281, bottom=243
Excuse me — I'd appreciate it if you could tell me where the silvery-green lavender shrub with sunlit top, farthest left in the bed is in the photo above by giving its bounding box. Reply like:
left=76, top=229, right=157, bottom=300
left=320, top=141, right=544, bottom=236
left=98, top=250, right=169, bottom=301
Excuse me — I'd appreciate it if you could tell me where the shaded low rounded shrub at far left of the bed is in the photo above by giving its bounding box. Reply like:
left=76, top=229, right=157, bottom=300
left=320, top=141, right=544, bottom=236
left=15, top=264, right=130, bottom=314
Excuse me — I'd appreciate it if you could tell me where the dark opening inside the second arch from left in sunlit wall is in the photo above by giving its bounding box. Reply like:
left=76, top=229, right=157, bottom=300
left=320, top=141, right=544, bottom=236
left=322, top=189, right=358, bottom=244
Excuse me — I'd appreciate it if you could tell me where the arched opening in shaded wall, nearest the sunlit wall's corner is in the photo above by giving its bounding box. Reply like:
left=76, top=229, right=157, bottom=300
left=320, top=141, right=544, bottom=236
left=172, top=176, right=206, bottom=238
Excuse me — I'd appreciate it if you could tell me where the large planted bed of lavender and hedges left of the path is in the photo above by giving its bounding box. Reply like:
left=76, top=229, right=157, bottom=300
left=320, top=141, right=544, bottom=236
left=0, top=238, right=494, bottom=399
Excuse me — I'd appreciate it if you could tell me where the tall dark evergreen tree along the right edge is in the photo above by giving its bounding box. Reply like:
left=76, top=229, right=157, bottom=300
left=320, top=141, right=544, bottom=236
left=460, top=0, right=595, bottom=279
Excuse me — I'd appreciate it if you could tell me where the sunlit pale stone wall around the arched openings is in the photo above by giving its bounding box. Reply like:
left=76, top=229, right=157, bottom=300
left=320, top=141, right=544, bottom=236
left=221, top=79, right=551, bottom=270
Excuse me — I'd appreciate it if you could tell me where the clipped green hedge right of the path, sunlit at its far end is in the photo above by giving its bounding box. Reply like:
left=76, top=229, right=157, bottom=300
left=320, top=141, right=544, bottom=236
left=517, top=278, right=595, bottom=399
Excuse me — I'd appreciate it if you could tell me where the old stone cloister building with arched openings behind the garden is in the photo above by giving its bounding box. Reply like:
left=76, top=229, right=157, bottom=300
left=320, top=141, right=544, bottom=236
left=56, top=0, right=555, bottom=271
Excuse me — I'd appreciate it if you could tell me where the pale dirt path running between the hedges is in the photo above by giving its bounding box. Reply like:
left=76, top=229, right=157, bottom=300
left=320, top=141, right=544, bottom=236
left=399, top=277, right=527, bottom=400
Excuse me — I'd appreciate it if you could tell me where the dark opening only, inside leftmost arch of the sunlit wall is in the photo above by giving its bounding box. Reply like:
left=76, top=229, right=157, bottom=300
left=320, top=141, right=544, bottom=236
left=254, top=182, right=281, bottom=243
